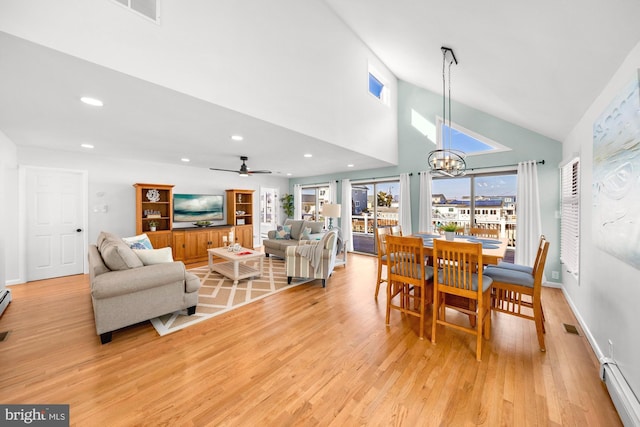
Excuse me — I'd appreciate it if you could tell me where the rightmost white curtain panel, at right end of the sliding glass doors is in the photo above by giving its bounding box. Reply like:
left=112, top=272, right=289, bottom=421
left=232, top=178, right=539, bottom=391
left=515, top=161, right=542, bottom=266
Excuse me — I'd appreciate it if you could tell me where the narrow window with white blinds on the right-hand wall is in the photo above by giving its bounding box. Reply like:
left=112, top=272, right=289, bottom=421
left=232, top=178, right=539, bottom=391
left=560, top=158, right=580, bottom=277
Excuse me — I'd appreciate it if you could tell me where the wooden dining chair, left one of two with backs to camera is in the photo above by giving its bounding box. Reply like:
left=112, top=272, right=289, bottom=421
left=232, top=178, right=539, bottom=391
left=386, top=235, right=433, bottom=339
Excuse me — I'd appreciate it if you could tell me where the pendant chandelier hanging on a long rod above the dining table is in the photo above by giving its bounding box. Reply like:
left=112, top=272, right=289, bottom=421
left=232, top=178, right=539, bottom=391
left=428, top=46, right=467, bottom=178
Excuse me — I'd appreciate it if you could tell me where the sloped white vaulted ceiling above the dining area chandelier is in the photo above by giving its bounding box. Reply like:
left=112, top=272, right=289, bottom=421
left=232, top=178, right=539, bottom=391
left=324, top=0, right=640, bottom=141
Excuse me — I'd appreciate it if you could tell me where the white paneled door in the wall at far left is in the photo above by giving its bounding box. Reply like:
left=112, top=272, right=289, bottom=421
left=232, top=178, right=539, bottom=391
left=25, top=168, right=86, bottom=281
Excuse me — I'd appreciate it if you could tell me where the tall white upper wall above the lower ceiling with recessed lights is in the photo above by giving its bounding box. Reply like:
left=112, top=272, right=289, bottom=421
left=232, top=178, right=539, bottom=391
left=0, top=0, right=397, bottom=163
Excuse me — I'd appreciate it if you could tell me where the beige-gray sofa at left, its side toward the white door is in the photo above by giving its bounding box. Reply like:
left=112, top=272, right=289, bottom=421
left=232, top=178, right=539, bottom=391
left=88, top=232, right=200, bottom=344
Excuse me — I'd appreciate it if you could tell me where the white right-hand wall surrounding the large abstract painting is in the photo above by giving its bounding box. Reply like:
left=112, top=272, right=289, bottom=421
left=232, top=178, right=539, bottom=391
left=563, top=44, right=640, bottom=396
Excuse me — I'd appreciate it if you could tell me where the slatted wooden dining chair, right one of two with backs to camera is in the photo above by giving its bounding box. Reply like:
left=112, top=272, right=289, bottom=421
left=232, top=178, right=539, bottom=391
left=431, top=239, right=492, bottom=361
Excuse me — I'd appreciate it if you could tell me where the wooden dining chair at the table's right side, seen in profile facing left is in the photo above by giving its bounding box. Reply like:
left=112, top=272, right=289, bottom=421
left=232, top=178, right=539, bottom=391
left=484, top=236, right=549, bottom=351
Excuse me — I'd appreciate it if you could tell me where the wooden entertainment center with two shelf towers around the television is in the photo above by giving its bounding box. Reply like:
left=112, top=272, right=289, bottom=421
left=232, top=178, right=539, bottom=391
left=133, top=183, right=254, bottom=263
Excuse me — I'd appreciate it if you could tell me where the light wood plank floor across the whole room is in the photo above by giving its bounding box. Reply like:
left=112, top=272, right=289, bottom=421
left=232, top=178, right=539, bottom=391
left=0, top=255, right=621, bottom=426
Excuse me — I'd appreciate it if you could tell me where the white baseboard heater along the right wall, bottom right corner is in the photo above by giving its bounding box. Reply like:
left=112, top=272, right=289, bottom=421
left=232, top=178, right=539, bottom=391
left=600, top=357, right=640, bottom=427
